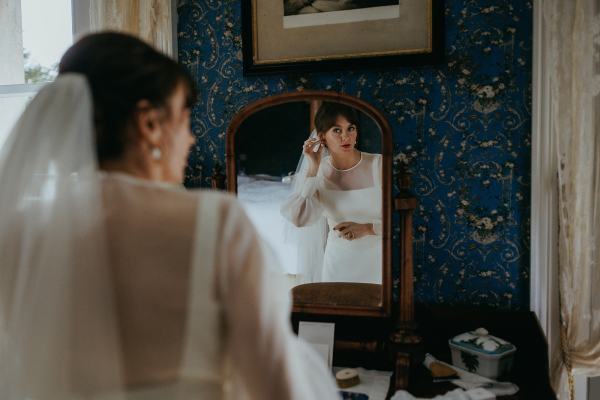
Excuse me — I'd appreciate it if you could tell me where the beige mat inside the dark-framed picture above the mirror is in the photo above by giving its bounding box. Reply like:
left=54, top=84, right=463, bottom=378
left=252, top=0, right=432, bottom=64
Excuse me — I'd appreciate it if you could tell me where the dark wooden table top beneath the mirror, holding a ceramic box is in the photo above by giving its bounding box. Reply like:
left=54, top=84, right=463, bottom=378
left=293, top=304, right=556, bottom=400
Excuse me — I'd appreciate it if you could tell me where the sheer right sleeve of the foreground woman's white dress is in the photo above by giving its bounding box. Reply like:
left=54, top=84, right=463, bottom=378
left=217, top=200, right=339, bottom=400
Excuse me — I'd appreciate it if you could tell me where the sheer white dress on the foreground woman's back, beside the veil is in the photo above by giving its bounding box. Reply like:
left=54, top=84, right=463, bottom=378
left=94, top=174, right=337, bottom=400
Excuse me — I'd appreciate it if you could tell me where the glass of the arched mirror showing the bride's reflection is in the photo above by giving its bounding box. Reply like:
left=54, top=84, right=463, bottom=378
left=236, top=102, right=382, bottom=285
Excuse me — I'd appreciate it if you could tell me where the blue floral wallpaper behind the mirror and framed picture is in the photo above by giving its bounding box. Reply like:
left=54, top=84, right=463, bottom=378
left=178, top=0, right=532, bottom=309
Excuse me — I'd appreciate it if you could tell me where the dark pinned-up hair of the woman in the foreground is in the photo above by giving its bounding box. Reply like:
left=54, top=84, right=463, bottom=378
left=59, top=32, right=196, bottom=162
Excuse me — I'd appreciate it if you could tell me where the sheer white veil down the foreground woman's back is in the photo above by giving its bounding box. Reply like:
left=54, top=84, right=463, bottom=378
left=0, top=74, right=122, bottom=400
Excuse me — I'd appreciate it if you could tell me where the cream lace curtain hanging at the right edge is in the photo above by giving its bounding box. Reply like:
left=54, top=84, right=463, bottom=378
left=538, top=0, right=600, bottom=399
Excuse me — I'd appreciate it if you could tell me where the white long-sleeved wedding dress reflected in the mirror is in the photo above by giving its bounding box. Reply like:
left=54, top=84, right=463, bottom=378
left=281, top=152, right=382, bottom=284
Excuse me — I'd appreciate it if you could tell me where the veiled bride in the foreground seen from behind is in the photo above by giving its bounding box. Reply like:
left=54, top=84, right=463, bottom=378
left=0, top=33, right=338, bottom=400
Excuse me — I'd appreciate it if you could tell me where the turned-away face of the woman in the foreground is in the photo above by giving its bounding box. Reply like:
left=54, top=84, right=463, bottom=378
left=161, top=85, right=196, bottom=183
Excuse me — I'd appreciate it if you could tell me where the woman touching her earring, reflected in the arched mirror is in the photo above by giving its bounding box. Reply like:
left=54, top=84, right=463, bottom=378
left=281, top=102, right=382, bottom=284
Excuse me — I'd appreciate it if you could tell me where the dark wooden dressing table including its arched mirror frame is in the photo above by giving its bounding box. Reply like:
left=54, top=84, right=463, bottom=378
left=223, top=91, right=553, bottom=399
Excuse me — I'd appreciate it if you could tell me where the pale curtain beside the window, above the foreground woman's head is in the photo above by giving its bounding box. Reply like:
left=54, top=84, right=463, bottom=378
left=90, top=0, right=174, bottom=56
